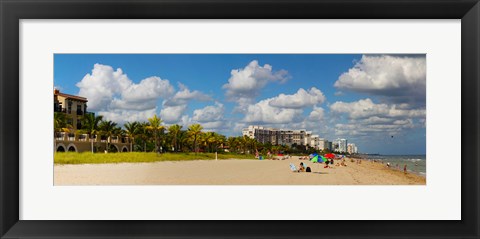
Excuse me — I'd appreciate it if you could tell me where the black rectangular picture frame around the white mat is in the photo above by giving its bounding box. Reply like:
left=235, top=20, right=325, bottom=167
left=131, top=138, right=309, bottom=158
left=0, top=0, right=480, bottom=238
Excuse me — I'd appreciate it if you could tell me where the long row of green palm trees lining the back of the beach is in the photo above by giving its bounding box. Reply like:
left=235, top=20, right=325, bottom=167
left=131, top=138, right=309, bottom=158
left=69, top=113, right=340, bottom=156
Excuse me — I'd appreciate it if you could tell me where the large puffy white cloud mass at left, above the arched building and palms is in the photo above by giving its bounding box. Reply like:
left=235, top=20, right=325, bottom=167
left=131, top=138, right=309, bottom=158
left=76, top=64, right=216, bottom=125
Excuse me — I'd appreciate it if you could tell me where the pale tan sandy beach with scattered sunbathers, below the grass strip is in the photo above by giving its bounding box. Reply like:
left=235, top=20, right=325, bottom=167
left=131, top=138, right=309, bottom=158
left=54, top=157, right=426, bottom=185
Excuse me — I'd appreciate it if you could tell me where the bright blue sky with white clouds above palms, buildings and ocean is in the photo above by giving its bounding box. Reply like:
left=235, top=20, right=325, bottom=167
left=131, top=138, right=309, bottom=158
left=54, top=54, right=426, bottom=154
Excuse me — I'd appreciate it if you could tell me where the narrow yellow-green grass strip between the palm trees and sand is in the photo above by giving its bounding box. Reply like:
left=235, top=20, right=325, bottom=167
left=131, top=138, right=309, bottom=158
left=54, top=152, right=255, bottom=164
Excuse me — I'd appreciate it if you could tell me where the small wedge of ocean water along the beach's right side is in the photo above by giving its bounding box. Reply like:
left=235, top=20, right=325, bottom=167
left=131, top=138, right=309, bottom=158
left=365, top=155, right=427, bottom=176
